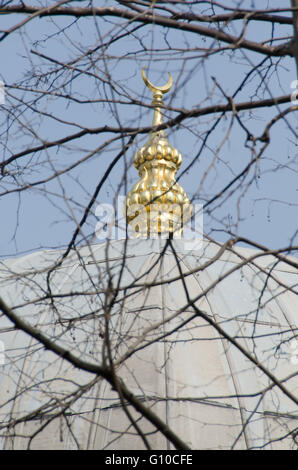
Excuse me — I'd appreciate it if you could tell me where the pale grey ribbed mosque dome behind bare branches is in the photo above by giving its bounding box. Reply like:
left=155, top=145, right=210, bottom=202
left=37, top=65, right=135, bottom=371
left=0, top=238, right=298, bottom=450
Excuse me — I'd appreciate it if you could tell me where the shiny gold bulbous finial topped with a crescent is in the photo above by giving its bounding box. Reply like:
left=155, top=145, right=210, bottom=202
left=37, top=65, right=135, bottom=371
left=126, top=69, right=193, bottom=238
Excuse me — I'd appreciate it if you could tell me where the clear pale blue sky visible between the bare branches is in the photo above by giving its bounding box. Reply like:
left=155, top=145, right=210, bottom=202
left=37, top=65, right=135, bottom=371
left=0, top=1, right=298, bottom=257
